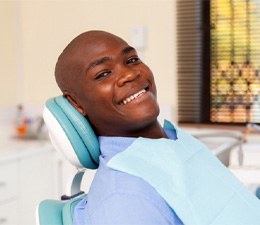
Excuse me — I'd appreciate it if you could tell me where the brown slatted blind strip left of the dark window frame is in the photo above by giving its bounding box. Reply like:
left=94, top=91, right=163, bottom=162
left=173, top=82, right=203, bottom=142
left=176, top=0, right=202, bottom=123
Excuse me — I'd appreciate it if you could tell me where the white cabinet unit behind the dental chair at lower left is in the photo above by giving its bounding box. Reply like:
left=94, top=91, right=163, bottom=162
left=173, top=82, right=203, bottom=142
left=0, top=142, right=95, bottom=225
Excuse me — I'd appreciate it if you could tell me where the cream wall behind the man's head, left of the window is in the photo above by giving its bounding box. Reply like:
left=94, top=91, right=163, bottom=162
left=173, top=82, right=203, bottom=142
left=0, top=0, right=177, bottom=121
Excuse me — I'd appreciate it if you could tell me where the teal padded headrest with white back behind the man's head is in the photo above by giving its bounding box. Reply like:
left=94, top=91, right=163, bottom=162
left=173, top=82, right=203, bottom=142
left=43, top=96, right=100, bottom=169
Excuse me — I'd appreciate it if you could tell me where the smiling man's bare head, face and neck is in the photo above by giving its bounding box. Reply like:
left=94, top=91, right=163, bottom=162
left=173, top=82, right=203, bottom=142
left=55, top=31, right=167, bottom=138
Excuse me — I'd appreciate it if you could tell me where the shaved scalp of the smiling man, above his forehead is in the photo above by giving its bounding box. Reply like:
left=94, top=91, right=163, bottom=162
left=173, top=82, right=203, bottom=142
left=55, top=30, right=125, bottom=95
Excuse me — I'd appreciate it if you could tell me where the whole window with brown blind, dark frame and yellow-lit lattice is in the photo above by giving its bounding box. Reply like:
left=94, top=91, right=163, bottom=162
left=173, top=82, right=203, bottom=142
left=177, top=0, right=260, bottom=124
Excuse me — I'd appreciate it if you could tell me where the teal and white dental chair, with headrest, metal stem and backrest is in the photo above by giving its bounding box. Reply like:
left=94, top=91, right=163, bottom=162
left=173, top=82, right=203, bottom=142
left=36, top=96, right=100, bottom=225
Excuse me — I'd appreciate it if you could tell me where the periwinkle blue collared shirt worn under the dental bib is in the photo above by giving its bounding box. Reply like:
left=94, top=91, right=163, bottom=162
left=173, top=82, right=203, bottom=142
left=73, top=130, right=183, bottom=225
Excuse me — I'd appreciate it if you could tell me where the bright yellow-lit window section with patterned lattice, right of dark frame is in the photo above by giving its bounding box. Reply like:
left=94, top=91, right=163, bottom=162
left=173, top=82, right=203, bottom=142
left=210, top=0, right=260, bottom=123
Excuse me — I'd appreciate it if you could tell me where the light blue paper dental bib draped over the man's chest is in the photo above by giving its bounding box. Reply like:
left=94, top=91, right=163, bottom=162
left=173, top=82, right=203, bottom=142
left=108, top=123, right=260, bottom=225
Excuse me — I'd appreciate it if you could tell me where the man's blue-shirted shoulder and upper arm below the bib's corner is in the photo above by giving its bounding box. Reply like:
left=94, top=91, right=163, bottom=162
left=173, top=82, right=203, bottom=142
left=79, top=158, right=180, bottom=224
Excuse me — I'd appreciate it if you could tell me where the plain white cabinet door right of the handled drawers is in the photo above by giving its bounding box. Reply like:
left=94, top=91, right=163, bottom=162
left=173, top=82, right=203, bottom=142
left=18, top=151, right=58, bottom=225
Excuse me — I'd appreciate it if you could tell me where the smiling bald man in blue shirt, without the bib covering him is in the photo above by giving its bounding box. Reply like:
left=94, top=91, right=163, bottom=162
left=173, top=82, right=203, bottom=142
left=55, top=31, right=182, bottom=225
